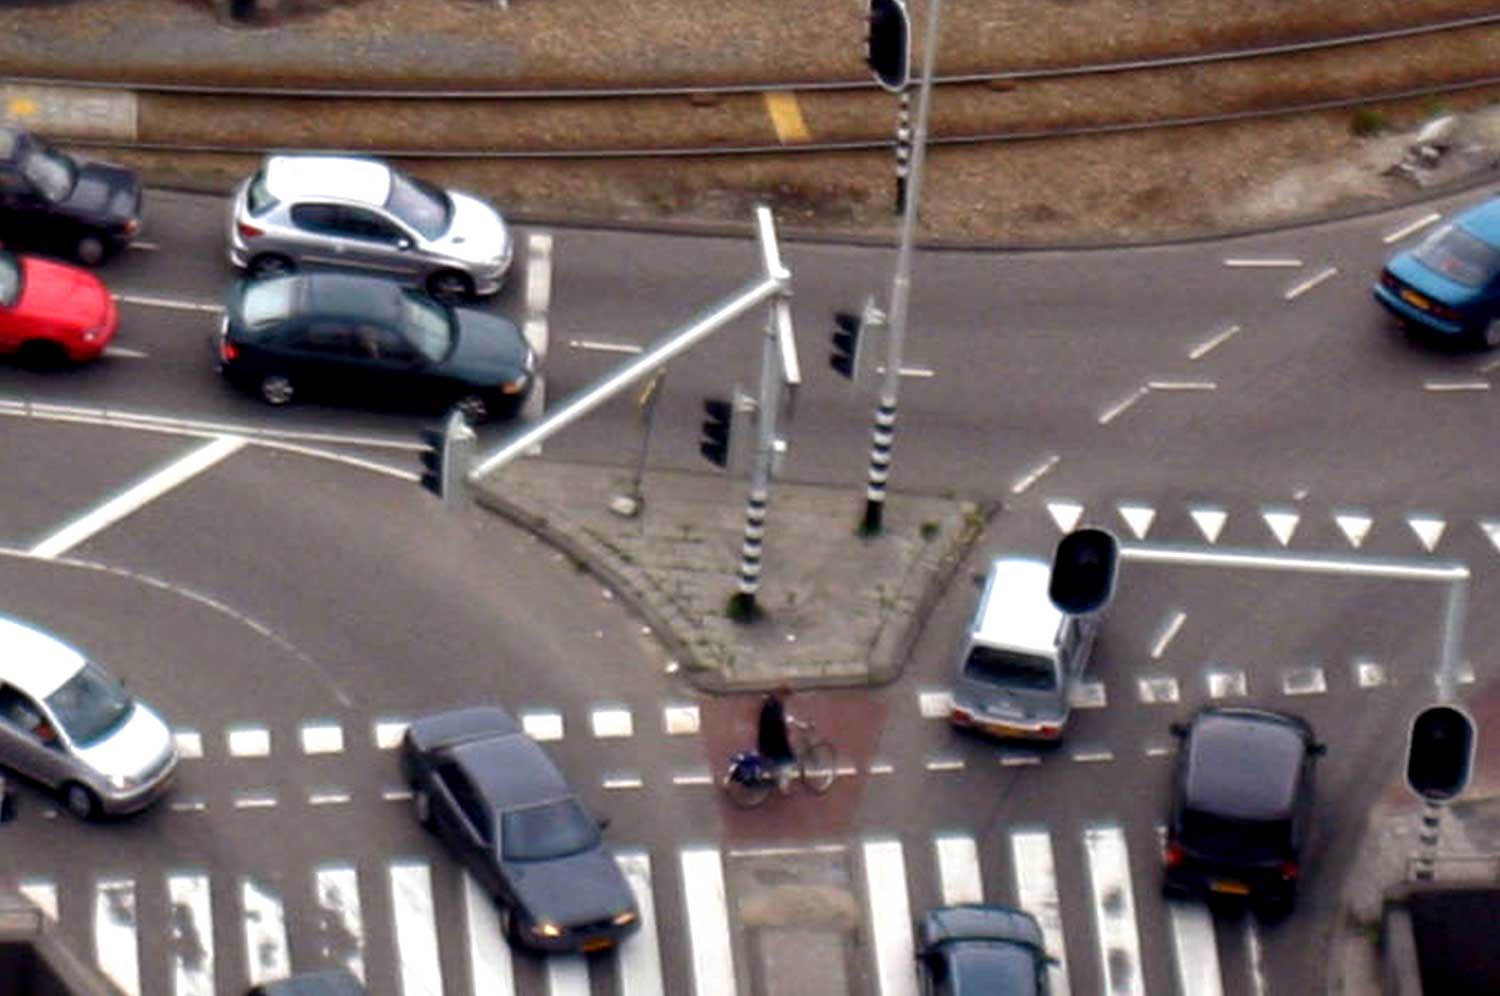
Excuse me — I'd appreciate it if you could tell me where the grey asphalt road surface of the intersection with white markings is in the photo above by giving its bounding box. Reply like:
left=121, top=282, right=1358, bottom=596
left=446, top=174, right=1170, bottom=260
left=0, top=186, right=1497, bottom=996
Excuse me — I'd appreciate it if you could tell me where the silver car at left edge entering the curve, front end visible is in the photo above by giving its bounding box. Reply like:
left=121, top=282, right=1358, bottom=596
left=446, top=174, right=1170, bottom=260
left=0, top=617, right=177, bottom=819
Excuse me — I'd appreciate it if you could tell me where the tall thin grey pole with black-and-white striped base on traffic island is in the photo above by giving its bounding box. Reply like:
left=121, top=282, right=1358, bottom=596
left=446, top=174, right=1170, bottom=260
left=860, top=0, right=942, bottom=536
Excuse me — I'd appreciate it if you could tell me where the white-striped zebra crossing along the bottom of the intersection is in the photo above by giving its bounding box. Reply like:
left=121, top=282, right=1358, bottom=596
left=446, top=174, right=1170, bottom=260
left=11, top=824, right=1226, bottom=996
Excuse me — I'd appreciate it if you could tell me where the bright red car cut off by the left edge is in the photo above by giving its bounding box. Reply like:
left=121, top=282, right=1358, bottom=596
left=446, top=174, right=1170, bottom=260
left=0, top=249, right=120, bottom=366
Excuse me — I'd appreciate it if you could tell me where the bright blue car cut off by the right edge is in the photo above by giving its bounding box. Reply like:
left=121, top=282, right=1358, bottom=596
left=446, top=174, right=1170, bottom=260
left=1373, top=197, right=1500, bottom=350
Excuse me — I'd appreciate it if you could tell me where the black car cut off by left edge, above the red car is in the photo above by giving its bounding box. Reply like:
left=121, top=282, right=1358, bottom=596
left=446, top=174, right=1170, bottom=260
left=0, top=125, right=141, bottom=266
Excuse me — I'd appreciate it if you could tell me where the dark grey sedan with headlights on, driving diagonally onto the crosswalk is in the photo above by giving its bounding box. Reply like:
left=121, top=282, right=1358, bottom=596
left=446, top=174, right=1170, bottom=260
left=401, top=707, right=639, bottom=951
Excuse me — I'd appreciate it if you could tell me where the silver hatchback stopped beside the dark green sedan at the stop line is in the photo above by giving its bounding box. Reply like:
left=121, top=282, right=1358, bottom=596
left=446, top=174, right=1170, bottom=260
left=230, top=156, right=513, bottom=302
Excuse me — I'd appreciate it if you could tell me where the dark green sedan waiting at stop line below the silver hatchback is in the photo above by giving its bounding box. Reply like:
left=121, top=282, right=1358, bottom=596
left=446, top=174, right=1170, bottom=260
left=218, top=273, right=537, bottom=422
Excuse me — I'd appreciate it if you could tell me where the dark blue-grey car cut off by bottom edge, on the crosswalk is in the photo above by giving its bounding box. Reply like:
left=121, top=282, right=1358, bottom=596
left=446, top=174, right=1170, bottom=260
left=917, top=903, right=1053, bottom=996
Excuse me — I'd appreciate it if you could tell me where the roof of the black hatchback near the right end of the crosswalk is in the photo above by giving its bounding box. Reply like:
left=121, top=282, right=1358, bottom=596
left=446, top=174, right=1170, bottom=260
left=1184, top=708, right=1311, bottom=821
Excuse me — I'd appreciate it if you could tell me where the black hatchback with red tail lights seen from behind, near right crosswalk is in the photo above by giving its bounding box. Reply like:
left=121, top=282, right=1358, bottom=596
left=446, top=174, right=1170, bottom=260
left=1163, top=707, right=1325, bottom=917
